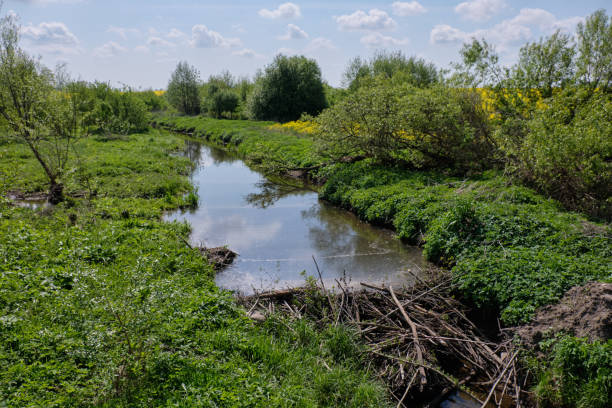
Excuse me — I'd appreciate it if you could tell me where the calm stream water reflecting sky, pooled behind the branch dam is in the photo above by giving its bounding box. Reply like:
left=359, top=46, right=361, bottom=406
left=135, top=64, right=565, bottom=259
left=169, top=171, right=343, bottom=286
left=166, top=141, right=425, bottom=294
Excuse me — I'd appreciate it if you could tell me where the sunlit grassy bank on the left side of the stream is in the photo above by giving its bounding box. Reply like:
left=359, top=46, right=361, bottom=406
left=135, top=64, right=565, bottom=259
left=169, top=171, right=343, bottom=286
left=0, top=131, right=387, bottom=407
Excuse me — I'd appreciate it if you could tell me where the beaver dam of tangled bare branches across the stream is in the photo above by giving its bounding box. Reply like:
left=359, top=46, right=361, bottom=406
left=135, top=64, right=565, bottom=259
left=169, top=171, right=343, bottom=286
left=240, top=271, right=522, bottom=407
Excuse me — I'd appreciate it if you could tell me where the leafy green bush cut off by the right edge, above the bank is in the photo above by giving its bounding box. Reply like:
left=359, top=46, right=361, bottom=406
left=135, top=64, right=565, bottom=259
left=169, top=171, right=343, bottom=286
left=508, top=87, right=612, bottom=219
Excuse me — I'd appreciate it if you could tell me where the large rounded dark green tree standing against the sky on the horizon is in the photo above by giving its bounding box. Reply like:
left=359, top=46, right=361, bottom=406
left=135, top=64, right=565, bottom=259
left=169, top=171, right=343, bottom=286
left=248, top=55, right=327, bottom=122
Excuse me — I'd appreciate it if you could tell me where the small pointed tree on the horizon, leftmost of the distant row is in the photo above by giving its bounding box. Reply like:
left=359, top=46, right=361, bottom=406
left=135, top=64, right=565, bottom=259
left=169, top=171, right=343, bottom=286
left=167, top=61, right=200, bottom=115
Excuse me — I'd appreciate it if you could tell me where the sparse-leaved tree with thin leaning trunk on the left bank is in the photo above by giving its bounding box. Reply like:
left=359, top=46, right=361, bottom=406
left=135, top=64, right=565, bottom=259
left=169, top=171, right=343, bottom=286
left=0, top=11, right=88, bottom=204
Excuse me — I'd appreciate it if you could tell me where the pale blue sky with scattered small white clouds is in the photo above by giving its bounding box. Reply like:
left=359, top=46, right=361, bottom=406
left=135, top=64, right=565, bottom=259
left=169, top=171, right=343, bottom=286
left=2, top=0, right=611, bottom=89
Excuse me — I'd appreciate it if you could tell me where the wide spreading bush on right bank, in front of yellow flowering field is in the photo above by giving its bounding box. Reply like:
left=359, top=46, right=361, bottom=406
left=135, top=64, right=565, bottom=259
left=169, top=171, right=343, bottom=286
left=315, top=78, right=494, bottom=171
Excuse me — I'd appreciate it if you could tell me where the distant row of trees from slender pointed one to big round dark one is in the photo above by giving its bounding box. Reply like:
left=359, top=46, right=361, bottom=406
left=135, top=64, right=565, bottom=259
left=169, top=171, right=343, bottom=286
left=167, top=55, right=333, bottom=122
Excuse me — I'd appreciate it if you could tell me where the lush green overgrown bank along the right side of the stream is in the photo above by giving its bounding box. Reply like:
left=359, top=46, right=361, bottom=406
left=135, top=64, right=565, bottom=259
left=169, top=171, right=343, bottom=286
left=155, top=117, right=612, bottom=406
